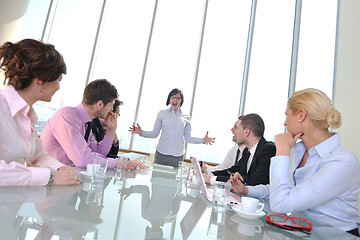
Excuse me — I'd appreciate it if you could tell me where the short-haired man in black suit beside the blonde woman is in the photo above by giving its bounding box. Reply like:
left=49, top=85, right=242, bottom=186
left=204, top=113, right=276, bottom=186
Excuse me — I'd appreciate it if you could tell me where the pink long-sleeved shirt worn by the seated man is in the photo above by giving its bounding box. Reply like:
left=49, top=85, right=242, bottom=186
left=41, top=104, right=116, bottom=168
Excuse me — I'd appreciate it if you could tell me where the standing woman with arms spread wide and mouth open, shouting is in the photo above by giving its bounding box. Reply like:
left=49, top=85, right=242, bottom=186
left=129, top=88, right=215, bottom=167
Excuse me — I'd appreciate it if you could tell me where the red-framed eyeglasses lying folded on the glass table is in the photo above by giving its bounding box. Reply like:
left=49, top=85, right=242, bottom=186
left=266, top=214, right=312, bottom=234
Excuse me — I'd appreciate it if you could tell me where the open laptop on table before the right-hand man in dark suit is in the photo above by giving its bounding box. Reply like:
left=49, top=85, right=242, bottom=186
left=190, top=157, right=241, bottom=205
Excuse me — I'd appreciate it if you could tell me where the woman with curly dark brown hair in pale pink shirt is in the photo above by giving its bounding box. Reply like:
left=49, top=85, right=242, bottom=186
left=0, top=39, right=81, bottom=186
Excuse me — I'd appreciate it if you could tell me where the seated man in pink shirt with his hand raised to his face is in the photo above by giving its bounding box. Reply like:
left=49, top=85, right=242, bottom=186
left=41, top=79, right=145, bottom=169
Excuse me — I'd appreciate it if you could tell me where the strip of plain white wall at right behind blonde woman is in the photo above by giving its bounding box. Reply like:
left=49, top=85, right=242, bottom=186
left=334, top=0, right=360, bottom=159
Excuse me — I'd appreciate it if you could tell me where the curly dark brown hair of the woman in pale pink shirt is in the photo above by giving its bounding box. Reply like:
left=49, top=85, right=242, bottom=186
left=0, top=39, right=66, bottom=90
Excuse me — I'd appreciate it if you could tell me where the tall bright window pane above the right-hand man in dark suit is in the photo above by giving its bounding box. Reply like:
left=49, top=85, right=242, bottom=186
left=244, top=0, right=295, bottom=140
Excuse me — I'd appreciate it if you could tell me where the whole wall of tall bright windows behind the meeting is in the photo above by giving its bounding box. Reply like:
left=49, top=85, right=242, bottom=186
left=11, top=0, right=337, bottom=163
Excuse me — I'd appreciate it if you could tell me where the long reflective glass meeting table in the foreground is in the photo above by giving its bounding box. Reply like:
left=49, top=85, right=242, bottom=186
left=0, top=156, right=356, bottom=240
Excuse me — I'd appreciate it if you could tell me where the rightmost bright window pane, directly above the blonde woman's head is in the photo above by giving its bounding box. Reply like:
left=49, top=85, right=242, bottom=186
left=296, top=0, right=337, bottom=98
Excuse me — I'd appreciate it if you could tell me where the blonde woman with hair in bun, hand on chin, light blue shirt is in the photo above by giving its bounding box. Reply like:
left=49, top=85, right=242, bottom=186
left=231, top=88, right=360, bottom=236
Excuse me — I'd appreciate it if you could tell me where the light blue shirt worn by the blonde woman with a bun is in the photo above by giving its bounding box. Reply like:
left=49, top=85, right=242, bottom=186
left=248, top=134, right=360, bottom=231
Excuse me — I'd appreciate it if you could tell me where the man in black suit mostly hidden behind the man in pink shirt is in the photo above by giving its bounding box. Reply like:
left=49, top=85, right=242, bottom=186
left=91, top=99, right=123, bottom=158
